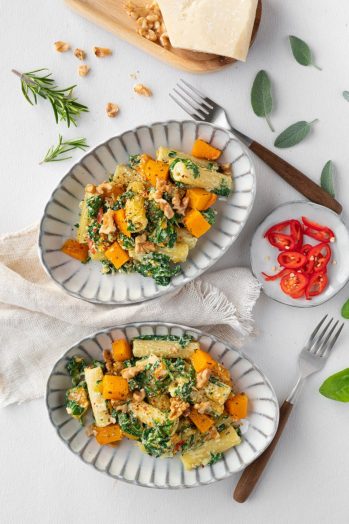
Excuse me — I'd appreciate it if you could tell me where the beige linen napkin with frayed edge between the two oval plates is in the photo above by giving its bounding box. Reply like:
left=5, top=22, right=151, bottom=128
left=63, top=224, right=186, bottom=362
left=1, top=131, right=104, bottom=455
left=0, top=225, right=259, bottom=407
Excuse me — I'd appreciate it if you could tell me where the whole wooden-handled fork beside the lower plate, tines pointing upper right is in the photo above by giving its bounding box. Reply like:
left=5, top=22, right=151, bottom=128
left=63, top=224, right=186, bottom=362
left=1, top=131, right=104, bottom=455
left=234, top=315, right=344, bottom=502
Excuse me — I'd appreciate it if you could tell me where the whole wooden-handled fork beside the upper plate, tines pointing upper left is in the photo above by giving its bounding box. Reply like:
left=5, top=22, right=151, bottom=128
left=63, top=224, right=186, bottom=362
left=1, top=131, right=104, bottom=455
left=169, top=79, right=342, bottom=214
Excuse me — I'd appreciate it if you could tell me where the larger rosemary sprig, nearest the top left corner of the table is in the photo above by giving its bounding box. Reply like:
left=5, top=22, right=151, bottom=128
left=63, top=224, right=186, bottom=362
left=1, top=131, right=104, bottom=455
left=12, top=69, right=88, bottom=127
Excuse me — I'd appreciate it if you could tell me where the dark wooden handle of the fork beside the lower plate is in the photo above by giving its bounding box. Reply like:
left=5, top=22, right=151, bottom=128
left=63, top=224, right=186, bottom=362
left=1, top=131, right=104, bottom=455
left=234, top=400, right=293, bottom=502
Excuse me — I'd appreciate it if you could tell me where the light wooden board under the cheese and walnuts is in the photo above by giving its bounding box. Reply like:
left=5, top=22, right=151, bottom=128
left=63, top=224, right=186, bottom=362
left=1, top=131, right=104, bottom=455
left=65, top=0, right=262, bottom=73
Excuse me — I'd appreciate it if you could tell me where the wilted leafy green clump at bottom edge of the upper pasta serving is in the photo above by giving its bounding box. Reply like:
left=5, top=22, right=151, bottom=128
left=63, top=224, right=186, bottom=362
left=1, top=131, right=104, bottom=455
left=134, top=253, right=181, bottom=286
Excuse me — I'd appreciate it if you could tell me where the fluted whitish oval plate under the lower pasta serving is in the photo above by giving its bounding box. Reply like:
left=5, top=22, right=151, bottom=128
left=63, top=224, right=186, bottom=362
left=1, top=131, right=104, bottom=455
left=46, top=322, right=279, bottom=489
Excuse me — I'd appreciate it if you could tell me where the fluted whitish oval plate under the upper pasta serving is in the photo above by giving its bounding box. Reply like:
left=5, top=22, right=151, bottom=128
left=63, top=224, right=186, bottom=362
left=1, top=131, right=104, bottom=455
left=39, top=120, right=256, bottom=304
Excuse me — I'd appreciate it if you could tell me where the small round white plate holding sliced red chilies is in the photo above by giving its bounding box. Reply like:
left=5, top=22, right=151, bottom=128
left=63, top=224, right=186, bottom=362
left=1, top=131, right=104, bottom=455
left=251, top=201, right=349, bottom=307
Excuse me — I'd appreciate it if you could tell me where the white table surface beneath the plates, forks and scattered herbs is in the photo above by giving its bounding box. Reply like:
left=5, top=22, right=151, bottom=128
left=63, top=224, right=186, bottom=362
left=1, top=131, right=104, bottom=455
left=0, top=0, right=349, bottom=524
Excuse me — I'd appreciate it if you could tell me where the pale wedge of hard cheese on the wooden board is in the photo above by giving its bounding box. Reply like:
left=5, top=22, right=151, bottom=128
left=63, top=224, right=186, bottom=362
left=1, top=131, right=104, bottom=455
left=158, top=0, right=258, bottom=61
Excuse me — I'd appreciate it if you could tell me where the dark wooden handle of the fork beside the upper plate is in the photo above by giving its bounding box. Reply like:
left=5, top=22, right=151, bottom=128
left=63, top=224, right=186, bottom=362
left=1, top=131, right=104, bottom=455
left=249, top=142, right=342, bottom=214
